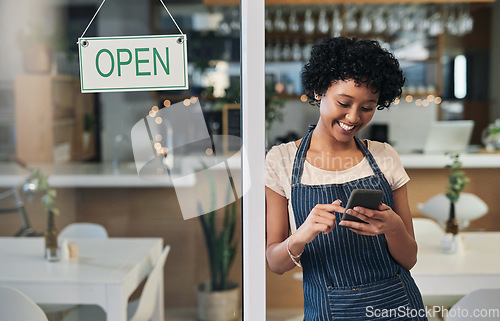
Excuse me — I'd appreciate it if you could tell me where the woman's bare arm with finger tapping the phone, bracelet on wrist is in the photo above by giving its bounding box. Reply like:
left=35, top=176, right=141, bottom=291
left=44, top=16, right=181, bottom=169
left=266, top=187, right=344, bottom=274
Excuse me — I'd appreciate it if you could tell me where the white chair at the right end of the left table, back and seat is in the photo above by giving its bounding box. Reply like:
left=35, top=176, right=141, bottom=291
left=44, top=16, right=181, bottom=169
left=63, top=245, right=170, bottom=321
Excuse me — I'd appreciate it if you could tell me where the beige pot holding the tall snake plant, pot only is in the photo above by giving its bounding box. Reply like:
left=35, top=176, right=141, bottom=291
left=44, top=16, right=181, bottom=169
left=198, top=281, right=240, bottom=321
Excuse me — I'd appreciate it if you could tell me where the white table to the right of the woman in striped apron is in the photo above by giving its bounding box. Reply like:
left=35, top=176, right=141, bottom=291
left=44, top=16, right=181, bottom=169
left=411, top=219, right=500, bottom=297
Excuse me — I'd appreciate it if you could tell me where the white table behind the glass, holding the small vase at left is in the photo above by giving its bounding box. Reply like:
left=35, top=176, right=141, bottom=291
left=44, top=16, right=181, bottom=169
left=0, top=237, right=164, bottom=321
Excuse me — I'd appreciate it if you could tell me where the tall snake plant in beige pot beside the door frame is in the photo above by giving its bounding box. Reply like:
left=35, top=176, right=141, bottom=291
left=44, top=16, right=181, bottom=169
left=198, top=168, right=240, bottom=321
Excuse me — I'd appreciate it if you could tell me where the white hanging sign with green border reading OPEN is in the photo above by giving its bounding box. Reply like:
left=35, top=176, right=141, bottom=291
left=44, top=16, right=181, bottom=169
left=78, top=35, right=189, bottom=93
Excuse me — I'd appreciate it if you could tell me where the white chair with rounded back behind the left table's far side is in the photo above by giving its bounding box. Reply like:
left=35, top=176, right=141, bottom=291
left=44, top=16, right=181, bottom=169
left=40, top=222, right=108, bottom=319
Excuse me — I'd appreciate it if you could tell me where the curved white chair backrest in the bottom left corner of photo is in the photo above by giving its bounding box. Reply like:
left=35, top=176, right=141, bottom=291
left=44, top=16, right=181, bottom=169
left=0, top=286, right=48, bottom=321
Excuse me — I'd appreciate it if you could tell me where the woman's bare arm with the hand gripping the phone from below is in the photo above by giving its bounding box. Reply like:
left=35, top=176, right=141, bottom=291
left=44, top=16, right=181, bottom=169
left=340, top=184, right=417, bottom=270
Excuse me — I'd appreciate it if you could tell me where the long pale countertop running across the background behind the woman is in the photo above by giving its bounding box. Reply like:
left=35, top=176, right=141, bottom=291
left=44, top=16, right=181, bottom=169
left=0, top=153, right=500, bottom=187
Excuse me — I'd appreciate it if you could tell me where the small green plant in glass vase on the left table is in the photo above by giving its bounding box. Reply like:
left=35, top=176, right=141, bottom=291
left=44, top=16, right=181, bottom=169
left=33, top=169, right=60, bottom=262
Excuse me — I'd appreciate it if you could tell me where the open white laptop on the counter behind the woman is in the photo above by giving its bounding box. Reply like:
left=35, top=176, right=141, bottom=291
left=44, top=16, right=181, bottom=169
left=424, top=120, right=474, bottom=154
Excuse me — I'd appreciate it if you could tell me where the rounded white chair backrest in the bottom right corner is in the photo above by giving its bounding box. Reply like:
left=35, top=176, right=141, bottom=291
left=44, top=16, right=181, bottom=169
left=445, top=289, right=500, bottom=321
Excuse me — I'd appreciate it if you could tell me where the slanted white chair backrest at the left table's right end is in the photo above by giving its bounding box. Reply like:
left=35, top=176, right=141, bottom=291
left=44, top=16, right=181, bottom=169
left=129, top=245, right=170, bottom=321
